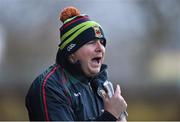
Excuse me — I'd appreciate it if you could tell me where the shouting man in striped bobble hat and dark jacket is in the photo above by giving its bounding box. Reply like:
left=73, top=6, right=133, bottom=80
left=26, top=7, right=127, bottom=121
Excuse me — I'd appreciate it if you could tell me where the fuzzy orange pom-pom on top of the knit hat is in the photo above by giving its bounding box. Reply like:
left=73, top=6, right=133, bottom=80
left=60, top=6, right=80, bottom=22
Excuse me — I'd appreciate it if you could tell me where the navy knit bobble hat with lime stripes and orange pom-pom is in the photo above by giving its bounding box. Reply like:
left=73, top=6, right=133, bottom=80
left=59, top=6, right=106, bottom=57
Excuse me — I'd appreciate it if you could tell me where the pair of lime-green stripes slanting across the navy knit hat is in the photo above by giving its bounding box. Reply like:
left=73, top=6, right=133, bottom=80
left=59, top=21, right=100, bottom=50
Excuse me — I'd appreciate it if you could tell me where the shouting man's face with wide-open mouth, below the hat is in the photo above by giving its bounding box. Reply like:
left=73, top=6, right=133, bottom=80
left=69, top=39, right=105, bottom=76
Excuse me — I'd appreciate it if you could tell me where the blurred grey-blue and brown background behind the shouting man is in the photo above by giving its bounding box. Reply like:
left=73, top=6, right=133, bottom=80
left=0, top=0, right=180, bottom=121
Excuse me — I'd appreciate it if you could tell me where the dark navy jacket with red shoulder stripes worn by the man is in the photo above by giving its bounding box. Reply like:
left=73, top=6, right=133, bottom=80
left=26, top=64, right=116, bottom=121
